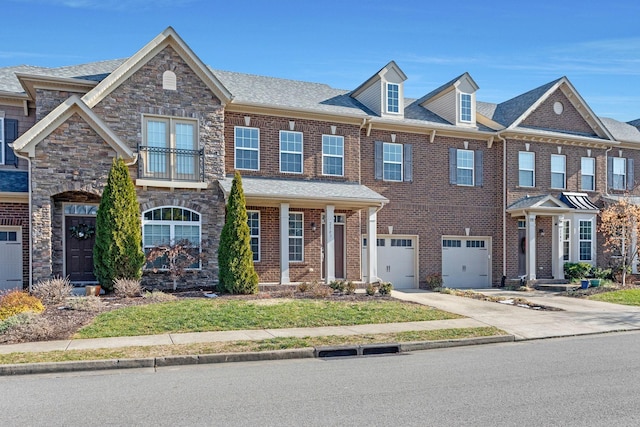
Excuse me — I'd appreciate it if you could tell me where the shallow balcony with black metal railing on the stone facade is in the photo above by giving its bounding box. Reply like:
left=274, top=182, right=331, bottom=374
left=138, top=145, right=204, bottom=182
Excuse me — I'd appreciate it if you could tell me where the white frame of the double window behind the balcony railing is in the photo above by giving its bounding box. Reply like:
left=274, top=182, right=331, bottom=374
left=142, top=115, right=200, bottom=179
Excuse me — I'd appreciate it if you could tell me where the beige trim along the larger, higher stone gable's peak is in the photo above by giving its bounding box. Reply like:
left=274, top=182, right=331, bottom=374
left=82, top=27, right=232, bottom=108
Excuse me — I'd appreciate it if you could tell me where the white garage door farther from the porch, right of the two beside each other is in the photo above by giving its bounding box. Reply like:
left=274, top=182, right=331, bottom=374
left=442, top=237, right=491, bottom=288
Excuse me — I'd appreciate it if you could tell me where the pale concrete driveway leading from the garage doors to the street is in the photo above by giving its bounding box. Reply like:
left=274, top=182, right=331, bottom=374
left=393, top=289, right=640, bottom=340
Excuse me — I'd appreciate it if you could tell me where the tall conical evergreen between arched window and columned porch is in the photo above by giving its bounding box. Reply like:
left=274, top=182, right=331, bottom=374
left=218, top=171, right=258, bottom=294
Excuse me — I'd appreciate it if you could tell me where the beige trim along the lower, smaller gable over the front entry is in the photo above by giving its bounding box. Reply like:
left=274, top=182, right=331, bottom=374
left=11, top=95, right=134, bottom=159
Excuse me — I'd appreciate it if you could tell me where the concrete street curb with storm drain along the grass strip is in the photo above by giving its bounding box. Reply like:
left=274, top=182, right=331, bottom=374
left=0, top=335, right=515, bottom=376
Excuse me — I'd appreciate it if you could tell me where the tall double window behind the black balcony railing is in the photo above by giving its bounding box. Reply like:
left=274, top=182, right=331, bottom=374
left=141, top=116, right=201, bottom=181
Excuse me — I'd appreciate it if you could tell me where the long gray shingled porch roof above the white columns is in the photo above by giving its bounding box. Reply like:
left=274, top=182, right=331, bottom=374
left=219, top=177, right=389, bottom=206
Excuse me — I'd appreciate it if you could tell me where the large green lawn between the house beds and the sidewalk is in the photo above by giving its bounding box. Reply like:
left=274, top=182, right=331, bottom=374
left=75, top=299, right=461, bottom=338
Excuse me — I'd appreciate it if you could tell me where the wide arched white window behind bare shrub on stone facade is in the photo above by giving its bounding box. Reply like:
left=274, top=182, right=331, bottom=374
left=142, top=206, right=202, bottom=270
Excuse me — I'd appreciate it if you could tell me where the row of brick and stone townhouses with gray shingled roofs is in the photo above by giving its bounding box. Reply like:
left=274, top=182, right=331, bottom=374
left=0, top=28, right=640, bottom=294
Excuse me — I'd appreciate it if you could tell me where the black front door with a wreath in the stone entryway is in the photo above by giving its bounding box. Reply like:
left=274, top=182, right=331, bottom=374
left=65, top=216, right=96, bottom=282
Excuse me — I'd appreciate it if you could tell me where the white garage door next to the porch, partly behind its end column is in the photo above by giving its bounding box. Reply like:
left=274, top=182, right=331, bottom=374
left=362, top=235, right=417, bottom=289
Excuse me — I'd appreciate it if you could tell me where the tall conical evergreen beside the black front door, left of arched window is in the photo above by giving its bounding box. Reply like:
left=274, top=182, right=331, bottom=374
left=93, top=159, right=144, bottom=291
